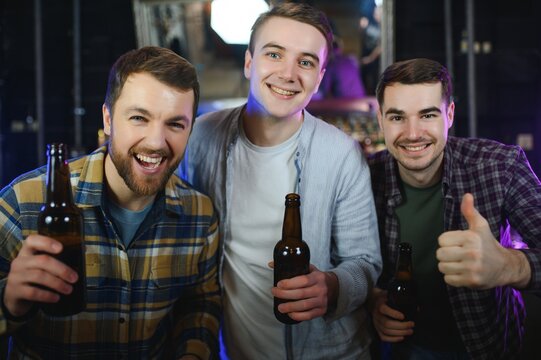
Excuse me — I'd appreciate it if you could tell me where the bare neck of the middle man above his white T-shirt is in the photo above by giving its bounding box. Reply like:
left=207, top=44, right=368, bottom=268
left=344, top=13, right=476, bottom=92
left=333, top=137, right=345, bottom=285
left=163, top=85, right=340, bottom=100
left=241, top=106, right=304, bottom=146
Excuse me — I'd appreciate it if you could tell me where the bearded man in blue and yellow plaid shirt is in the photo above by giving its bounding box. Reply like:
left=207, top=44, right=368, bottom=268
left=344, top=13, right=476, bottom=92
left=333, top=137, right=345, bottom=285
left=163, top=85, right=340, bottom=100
left=0, top=47, right=221, bottom=359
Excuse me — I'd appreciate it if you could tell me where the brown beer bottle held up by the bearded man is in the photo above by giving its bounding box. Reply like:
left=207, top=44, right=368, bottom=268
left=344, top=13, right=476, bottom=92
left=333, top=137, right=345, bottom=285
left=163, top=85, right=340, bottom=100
left=38, top=143, right=86, bottom=316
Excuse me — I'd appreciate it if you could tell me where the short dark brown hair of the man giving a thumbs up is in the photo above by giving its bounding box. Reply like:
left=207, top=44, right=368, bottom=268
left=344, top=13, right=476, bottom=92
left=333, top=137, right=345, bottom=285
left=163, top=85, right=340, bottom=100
left=376, top=58, right=453, bottom=109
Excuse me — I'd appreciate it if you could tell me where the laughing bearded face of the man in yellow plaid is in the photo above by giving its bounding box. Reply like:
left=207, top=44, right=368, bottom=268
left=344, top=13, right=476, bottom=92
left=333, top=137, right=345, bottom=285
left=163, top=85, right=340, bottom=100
left=103, top=73, right=194, bottom=202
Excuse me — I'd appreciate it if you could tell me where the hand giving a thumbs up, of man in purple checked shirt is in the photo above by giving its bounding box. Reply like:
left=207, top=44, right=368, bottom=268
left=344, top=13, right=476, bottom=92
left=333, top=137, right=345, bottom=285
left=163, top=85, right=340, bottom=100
left=436, top=194, right=531, bottom=289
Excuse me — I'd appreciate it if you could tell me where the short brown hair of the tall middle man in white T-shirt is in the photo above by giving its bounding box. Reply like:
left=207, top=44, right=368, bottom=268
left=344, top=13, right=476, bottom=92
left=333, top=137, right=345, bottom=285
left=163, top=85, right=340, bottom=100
left=248, top=3, right=333, bottom=68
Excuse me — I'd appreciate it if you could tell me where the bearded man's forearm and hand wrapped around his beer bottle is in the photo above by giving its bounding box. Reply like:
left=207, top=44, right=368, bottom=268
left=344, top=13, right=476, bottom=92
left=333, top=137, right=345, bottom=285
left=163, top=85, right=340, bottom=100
left=0, top=187, right=77, bottom=335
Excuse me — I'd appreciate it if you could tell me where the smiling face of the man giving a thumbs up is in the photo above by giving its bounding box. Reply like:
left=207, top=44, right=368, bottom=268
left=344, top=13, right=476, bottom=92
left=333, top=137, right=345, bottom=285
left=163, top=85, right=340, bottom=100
left=378, top=83, right=455, bottom=187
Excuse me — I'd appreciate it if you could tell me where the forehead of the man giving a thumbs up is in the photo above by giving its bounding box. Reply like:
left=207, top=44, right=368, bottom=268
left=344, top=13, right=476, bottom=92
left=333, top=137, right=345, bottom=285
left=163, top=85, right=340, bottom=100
left=383, top=82, right=443, bottom=111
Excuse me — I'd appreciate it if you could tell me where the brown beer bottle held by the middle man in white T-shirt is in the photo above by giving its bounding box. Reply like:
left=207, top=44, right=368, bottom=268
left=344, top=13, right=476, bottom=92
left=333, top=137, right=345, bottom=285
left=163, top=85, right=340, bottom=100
left=274, top=193, right=310, bottom=324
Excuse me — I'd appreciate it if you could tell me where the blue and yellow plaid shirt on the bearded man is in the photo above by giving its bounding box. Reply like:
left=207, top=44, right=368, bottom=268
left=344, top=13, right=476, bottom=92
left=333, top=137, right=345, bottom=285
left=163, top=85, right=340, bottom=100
left=0, top=147, right=221, bottom=359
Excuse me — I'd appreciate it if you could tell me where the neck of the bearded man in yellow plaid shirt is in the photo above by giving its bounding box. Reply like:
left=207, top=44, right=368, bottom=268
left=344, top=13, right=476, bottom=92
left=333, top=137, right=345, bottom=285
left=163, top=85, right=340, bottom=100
left=105, top=155, right=156, bottom=211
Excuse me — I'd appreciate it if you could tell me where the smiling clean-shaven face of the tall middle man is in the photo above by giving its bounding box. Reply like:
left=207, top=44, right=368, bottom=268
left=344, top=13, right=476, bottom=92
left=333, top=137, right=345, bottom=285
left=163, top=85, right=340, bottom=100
left=244, top=17, right=327, bottom=119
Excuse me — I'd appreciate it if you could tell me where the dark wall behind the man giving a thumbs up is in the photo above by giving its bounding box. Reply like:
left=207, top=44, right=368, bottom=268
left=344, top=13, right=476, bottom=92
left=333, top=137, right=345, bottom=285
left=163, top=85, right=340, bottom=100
left=395, top=0, right=541, bottom=176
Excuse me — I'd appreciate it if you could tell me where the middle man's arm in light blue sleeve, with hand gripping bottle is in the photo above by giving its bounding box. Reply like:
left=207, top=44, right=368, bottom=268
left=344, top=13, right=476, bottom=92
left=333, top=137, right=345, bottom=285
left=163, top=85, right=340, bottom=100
left=272, top=141, right=381, bottom=321
